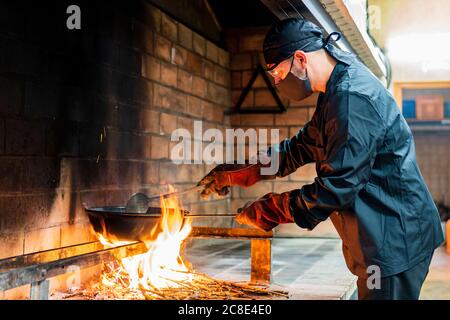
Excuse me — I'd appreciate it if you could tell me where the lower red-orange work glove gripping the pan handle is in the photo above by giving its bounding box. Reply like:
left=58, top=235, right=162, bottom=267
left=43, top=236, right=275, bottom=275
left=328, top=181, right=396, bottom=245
left=235, top=192, right=294, bottom=231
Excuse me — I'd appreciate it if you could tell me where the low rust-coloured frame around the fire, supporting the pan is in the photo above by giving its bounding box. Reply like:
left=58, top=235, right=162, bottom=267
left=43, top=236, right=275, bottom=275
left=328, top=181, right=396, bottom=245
left=0, top=227, right=273, bottom=292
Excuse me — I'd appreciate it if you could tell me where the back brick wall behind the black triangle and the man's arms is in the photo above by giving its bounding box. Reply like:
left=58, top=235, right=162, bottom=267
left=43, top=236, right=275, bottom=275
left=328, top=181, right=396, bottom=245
left=226, top=28, right=335, bottom=236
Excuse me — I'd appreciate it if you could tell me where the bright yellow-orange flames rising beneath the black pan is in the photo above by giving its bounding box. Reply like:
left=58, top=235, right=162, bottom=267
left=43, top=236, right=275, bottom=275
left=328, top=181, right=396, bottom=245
left=97, top=187, right=192, bottom=290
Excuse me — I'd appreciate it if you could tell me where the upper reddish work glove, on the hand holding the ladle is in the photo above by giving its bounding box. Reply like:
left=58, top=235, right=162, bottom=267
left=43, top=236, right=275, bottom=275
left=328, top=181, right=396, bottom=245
left=197, top=162, right=275, bottom=197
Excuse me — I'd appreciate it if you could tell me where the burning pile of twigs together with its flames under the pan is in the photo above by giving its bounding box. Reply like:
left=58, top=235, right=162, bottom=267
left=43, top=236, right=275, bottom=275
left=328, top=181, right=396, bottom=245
left=66, top=185, right=287, bottom=300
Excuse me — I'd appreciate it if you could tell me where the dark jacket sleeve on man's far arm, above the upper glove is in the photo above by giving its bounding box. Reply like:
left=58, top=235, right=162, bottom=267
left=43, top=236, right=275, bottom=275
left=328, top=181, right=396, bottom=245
left=269, top=110, right=321, bottom=177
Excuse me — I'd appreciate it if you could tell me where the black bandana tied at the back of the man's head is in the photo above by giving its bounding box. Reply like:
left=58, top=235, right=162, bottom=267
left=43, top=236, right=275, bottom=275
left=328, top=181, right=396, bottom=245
left=263, top=18, right=348, bottom=65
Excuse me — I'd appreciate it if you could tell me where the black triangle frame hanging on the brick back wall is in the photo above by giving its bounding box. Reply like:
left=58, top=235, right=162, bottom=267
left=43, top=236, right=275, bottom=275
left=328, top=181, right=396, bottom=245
left=234, top=64, right=286, bottom=113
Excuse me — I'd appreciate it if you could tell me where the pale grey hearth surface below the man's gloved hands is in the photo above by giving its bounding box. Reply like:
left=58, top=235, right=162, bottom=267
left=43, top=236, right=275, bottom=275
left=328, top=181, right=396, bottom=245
left=185, top=238, right=356, bottom=299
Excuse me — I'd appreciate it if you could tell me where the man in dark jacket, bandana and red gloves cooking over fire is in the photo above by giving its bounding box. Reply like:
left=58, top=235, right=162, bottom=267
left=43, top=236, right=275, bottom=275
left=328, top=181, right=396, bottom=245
left=199, top=18, right=443, bottom=299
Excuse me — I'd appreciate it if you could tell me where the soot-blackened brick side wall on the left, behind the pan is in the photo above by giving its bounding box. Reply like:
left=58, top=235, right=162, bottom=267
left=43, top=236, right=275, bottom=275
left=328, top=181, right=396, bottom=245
left=0, top=1, right=231, bottom=298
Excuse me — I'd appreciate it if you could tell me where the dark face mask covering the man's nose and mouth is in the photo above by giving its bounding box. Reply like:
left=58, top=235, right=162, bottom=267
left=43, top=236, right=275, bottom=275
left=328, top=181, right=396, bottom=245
left=275, top=58, right=312, bottom=100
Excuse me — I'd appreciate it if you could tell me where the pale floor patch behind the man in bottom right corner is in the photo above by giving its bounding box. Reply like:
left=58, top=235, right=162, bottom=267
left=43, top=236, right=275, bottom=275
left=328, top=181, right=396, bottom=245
left=420, top=247, right=450, bottom=300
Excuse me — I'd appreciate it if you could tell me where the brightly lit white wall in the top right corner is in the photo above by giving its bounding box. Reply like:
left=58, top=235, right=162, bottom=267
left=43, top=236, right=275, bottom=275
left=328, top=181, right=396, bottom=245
left=369, top=0, right=450, bottom=82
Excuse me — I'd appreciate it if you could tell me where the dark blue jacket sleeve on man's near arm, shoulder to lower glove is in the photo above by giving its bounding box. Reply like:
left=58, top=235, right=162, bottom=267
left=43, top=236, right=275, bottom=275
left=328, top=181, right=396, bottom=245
left=290, top=92, right=385, bottom=230
